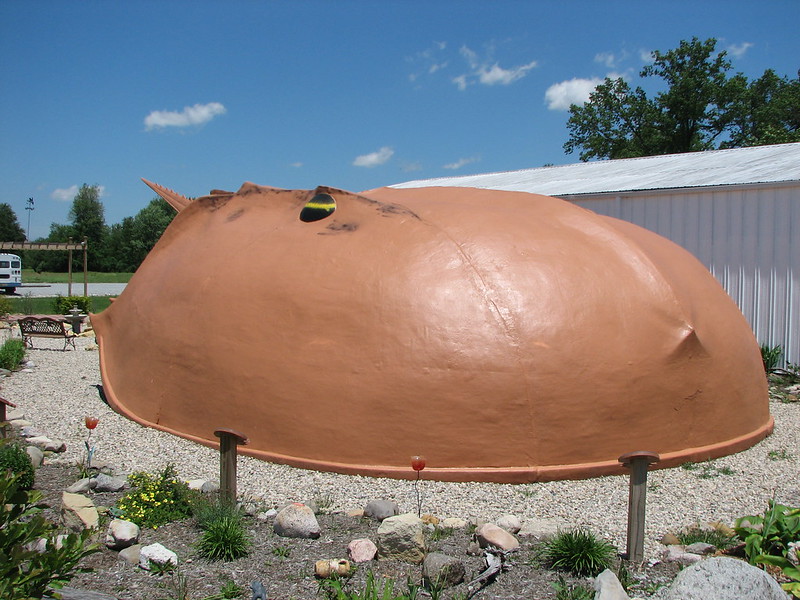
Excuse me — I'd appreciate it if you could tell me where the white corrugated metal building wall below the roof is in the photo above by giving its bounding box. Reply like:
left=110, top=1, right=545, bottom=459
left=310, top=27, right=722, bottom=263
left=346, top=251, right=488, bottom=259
left=565, top=184, right=800, bottom=366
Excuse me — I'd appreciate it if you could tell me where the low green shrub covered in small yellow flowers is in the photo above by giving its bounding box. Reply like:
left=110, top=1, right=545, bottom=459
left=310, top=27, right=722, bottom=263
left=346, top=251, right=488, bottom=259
left=113, top=465, right=194, bottom=529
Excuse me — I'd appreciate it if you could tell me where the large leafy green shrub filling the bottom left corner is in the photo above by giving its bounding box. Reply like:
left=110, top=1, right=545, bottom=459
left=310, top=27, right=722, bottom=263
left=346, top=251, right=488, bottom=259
left=0, top=476, right=99, bottom=600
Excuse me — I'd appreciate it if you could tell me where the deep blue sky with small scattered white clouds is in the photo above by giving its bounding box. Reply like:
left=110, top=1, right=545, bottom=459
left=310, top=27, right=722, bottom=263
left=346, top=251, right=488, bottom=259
left=0, top=0, right=800, bottom=239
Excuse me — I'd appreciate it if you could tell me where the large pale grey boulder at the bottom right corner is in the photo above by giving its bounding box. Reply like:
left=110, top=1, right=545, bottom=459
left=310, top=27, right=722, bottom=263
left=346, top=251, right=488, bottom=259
left=653, top=556, right=787, bottom=600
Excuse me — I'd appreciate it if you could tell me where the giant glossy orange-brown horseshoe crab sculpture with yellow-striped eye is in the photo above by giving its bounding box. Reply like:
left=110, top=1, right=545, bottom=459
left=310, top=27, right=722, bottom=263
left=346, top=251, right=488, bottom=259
left=92, top=183, right=773, bottom=482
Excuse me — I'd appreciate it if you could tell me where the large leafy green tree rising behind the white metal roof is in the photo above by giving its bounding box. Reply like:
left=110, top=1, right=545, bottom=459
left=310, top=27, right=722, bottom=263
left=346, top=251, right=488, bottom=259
left=564, top=38, right=800, bottom=161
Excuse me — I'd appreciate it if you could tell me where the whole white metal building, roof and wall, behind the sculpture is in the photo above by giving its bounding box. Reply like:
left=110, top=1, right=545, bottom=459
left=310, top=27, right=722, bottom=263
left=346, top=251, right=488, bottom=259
left=392, top=143, right=800, bottom=364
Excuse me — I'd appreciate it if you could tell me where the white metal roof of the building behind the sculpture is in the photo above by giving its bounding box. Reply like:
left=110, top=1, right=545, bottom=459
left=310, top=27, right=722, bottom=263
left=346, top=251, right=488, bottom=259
left=391, top=143, right=800, bottom=196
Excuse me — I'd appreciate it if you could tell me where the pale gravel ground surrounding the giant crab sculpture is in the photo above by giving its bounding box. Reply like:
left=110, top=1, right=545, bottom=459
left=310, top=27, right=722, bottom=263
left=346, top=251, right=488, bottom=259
left=0, top=330, right=800, bottom=558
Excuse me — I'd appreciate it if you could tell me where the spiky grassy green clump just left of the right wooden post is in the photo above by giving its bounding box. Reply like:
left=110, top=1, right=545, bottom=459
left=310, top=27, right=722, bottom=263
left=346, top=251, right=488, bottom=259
left=540, top=529, right=617, bottom=577
